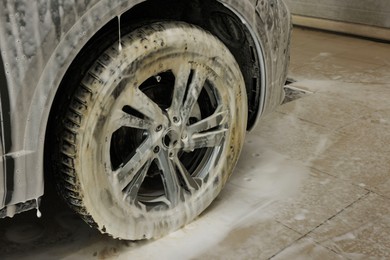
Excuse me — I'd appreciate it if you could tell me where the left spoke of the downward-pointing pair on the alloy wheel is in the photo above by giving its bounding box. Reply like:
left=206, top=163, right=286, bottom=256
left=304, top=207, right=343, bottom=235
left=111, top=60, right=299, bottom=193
left=157, top=152, right=182, bottom=207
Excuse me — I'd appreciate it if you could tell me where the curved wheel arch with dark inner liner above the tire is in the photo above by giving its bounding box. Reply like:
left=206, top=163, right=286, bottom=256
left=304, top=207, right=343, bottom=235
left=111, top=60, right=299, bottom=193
left=40, top=0, right=265, bottom=183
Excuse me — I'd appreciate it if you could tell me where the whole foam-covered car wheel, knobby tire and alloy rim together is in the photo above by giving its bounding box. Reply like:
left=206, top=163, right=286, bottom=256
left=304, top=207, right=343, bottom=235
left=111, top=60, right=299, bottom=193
left=54, top=22, right=248, bottom=240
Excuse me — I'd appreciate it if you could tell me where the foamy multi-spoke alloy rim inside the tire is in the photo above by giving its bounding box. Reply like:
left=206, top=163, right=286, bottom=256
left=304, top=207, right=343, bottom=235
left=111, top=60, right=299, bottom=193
left=100, top=60, right=230, bottom=210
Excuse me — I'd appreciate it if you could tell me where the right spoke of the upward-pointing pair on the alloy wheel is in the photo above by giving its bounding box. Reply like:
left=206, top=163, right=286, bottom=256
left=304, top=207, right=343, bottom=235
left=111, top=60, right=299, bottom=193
left=180, top=68, right=207, bottom=124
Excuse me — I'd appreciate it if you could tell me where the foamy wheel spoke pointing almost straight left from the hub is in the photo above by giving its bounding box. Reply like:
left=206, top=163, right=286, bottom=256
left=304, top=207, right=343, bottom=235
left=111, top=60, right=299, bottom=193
left=110, top=109, right=152, bottom=132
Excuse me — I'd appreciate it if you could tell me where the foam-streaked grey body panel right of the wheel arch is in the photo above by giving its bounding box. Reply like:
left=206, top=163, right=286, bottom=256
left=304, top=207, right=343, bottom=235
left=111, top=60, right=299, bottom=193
left=221, top=0, right=292, bottom=125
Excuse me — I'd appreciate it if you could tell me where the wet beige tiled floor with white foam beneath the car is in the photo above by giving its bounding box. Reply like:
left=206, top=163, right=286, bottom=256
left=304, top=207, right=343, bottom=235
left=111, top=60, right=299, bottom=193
left=0, top=28, right=390, bottom=259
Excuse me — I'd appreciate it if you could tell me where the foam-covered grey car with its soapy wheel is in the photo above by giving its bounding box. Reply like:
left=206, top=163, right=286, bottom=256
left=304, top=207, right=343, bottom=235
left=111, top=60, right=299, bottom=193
left=0, top=0, right=291, bottom=240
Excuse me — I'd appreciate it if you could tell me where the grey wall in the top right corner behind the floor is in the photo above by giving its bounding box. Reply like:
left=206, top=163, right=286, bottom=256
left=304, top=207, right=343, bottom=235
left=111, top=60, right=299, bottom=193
left=285, top=0, right=390, bottom=28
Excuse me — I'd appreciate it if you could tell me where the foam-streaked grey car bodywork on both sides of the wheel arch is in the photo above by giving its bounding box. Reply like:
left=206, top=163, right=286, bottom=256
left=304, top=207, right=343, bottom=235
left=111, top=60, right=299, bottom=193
left=0, top=0, right=291, bottom=217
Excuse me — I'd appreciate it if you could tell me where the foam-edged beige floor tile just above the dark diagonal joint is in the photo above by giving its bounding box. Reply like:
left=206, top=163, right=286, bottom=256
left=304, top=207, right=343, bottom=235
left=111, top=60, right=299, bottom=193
left=275, top=170, right=368, bottom=235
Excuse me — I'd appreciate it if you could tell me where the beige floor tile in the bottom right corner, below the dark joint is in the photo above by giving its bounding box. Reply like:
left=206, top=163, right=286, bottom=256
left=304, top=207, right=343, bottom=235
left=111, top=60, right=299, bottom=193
left=310, top=194, right=390, bottom=259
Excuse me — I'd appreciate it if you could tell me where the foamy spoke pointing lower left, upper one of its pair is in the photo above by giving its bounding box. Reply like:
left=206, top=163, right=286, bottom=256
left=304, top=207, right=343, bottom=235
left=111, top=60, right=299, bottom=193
left=115, top=138, right=154, bottom=190
